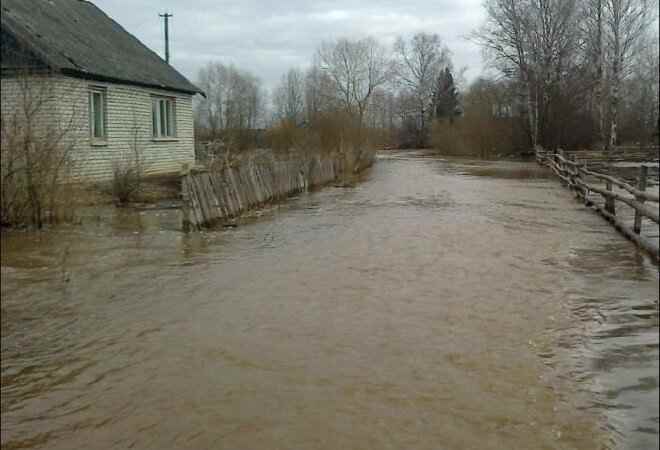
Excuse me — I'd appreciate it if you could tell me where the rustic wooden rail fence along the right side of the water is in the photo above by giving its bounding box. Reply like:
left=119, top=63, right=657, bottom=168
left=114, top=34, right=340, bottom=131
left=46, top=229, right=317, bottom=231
left=536, top=147, right=660, bottom=262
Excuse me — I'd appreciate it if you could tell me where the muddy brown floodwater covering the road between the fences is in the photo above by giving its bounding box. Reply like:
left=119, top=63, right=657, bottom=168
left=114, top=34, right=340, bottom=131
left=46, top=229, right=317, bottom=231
left=1, top=153, right=659, bottom=450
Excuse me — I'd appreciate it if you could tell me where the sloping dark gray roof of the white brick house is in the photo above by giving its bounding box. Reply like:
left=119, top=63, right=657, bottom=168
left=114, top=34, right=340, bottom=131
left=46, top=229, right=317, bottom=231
left=2, top=0, right=202, bottom=93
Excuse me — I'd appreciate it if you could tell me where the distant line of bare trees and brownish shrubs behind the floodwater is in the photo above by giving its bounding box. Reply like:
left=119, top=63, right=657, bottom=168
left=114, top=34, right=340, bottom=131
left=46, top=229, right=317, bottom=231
left=195, top=0, right=660, bottom=157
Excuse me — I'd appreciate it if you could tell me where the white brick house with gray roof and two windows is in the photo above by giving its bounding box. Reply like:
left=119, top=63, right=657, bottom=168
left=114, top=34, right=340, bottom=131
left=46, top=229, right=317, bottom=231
left=1, top=0, right=202, bottom=180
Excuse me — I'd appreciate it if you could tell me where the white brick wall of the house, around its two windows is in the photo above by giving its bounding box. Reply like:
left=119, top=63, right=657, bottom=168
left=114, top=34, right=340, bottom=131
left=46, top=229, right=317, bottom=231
left=1, top=76, right=195, bottom=181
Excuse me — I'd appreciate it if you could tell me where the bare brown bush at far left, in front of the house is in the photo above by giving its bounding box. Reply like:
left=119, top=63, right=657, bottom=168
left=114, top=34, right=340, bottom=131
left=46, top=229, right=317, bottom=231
left=0, top=74, right=77, bottom=228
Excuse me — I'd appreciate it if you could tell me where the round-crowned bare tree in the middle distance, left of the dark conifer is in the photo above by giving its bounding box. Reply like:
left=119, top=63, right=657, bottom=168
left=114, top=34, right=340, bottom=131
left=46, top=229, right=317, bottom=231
left=318, top=38, right=392, bottom=126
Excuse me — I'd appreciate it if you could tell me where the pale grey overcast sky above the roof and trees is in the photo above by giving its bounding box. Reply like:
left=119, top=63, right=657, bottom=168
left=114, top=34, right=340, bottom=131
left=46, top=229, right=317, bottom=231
left=92, top=0, right=483, bottom=88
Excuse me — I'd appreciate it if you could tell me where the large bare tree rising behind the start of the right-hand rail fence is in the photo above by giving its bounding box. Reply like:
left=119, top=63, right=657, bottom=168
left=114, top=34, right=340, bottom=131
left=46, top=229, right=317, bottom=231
left=474, top=0, right=597, bottom=146
